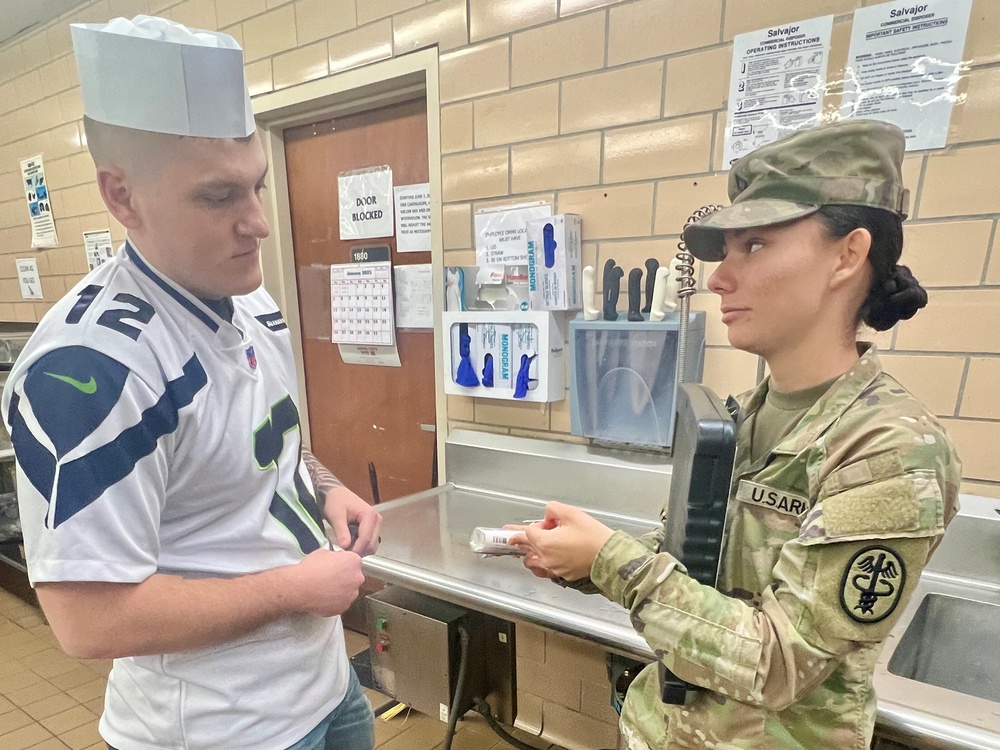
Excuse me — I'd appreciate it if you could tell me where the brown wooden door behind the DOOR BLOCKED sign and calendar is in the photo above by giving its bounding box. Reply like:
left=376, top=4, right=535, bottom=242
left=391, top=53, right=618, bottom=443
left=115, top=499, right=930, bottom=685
left=284, top=98, right=435, bottom=502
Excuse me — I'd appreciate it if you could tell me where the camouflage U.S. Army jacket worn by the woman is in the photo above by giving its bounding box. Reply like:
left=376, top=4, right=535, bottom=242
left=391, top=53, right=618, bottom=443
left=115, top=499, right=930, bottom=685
left=591, top=347, right=961, bottom=750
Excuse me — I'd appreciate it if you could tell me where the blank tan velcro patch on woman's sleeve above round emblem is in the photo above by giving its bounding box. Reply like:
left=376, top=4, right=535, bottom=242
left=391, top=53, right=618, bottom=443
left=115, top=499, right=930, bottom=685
left=823, top=476, right=920, bottom=537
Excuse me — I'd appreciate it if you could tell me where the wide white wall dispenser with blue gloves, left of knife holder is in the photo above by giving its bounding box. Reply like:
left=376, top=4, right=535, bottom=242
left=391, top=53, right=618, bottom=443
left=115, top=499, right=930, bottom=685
left=441, top=310, right=566, bottom=403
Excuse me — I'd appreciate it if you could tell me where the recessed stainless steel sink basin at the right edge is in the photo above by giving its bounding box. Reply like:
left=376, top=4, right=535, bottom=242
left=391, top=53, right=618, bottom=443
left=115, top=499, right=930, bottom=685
left=888, top=594, right=1000, bottom=702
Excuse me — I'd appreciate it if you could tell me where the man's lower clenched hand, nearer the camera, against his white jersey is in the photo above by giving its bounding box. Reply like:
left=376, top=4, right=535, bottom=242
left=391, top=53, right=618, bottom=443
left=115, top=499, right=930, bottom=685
left=289, top=549, right=365, bottom=617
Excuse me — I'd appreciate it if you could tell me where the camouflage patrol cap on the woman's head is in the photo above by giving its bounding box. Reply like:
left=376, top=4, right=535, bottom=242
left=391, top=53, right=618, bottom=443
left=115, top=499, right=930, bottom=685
left=684, top=120, right=910, bottom=261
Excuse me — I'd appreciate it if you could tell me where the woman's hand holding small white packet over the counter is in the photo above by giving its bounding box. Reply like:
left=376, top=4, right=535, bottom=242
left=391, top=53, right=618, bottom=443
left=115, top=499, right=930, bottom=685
left=510, top=502, right=614, bottom=581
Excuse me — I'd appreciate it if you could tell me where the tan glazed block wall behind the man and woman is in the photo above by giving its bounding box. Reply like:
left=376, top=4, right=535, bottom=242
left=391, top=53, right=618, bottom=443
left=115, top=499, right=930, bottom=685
left=0, top=0, right=1000, bottom=748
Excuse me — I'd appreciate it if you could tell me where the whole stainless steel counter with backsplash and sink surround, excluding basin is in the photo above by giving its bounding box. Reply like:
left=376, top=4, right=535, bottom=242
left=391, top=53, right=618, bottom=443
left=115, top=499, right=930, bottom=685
left=364, top=430, right=1000, bottom=750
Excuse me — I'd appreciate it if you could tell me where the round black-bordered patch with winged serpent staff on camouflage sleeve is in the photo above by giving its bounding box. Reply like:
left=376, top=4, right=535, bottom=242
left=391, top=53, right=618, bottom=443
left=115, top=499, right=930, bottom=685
left=840, top=544, right=906, bottom=625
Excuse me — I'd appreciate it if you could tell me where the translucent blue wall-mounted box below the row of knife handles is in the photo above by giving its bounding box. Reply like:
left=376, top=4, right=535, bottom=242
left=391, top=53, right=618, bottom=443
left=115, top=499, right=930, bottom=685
left=569, top=311, right=705, bottom=448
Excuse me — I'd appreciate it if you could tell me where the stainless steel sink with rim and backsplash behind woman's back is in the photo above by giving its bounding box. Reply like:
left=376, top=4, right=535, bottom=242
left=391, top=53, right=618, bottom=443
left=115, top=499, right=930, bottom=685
left=875, top=495, right=1000, bottom=750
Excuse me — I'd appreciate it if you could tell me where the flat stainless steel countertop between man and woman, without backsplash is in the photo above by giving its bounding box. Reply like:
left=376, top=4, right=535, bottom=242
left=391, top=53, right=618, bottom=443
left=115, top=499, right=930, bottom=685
left=364, top=484, right=655, bottom=660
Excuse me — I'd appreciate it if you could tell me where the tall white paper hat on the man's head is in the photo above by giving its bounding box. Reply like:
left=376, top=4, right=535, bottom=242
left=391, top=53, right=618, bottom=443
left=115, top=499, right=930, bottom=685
left=71, top=16, right=256, bottom=138
